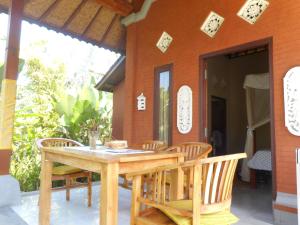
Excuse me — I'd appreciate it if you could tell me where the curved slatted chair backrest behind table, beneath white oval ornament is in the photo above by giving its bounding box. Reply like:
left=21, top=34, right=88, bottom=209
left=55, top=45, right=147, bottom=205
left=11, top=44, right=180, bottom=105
left=171, top=142, right=212, bottom=161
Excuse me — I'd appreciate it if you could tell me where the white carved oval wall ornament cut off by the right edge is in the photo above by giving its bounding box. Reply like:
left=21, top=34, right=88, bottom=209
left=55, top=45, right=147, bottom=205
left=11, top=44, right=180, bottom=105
left=283, top=66, right=300, bottom=136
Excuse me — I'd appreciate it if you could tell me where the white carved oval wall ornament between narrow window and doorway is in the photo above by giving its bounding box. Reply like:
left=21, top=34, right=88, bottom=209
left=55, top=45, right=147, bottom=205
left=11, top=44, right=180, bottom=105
left=177, top=85, right=193, bottom=134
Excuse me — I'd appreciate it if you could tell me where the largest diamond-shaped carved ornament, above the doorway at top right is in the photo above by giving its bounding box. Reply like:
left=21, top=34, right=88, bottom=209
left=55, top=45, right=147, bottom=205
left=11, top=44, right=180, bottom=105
left=237, top=0, right=269, bottom=24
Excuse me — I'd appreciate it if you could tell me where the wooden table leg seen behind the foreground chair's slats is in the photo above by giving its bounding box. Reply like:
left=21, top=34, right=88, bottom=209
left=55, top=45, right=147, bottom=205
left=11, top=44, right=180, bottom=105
left=170, top=157, right=184, bottom=200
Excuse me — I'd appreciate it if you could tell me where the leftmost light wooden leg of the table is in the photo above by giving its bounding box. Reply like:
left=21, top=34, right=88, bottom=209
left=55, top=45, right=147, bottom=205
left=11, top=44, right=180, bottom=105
left=39, top=153, right=52, bottom=225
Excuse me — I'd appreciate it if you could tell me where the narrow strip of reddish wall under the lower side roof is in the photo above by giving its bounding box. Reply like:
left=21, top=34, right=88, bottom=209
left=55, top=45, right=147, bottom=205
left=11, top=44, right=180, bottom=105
left=112, top=81, right=125, bottom=140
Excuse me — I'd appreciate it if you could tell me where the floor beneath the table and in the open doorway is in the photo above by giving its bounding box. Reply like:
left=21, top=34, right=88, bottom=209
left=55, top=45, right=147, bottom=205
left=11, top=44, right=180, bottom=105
left=11, top=185, right=273, bottom=225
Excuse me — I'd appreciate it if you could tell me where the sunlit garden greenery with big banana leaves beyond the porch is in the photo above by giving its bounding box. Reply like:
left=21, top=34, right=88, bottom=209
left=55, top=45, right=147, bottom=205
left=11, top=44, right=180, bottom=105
left=11, top=59, right=112, bottom=191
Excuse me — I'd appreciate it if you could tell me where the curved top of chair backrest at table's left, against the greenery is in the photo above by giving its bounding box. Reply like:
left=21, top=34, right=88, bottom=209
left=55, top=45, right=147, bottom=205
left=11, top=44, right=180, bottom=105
left=36, top=138, right=83, bottom=149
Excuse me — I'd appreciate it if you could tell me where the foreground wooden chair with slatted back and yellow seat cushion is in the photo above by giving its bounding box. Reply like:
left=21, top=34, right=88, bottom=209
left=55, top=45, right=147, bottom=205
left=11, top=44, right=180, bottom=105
left=127, top=153, right=246, bottom=225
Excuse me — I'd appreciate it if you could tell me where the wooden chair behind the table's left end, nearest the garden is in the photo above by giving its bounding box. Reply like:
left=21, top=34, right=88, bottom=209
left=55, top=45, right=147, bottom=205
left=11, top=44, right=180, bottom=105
left=36, top=138, right=92, bottom=207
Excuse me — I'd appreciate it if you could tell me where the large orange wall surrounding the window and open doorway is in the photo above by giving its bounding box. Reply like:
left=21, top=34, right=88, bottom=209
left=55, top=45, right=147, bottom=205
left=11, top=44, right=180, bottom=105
left=124, top=0, right=300, bottom=193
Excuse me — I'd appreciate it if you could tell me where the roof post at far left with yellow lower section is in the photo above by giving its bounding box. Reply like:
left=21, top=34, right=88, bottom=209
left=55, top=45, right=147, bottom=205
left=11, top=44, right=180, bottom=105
left=0, top=0, right=24, bottom=175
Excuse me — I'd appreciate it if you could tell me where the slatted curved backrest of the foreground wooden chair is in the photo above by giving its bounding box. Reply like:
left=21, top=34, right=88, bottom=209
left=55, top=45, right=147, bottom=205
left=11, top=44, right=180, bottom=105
left=128, top=153, right=247, bottom=221
